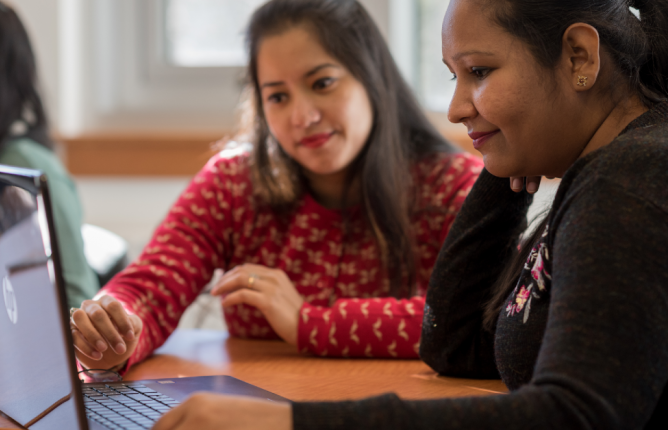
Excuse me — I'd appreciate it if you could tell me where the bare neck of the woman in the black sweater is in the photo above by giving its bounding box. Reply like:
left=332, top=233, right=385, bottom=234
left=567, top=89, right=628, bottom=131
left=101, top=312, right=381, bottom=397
left=578, top=97, right=648, bottom=158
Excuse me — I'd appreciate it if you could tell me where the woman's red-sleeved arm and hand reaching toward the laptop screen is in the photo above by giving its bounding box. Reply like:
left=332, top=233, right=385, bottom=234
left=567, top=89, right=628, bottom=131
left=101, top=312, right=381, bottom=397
left=73, top=156, right=240, bottom=370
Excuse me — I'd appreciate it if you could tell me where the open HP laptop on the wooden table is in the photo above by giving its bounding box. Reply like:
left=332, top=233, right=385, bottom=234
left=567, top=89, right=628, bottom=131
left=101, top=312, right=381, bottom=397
left=0, top=166, right=288, bottom=430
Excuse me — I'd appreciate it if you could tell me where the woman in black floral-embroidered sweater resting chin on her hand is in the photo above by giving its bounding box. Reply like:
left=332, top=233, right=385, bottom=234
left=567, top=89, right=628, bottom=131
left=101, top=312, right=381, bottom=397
left=155, top=0, right=668, bottom=430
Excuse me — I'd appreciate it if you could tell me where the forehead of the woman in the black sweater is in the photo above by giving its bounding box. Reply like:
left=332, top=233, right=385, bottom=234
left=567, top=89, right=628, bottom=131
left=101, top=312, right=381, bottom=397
left=441, top=0, right=515, bottom=61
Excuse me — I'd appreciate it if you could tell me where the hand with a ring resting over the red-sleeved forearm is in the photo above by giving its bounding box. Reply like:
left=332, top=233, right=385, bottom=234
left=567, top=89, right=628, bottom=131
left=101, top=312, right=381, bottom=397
left=211, top=264, right=304, bottom=345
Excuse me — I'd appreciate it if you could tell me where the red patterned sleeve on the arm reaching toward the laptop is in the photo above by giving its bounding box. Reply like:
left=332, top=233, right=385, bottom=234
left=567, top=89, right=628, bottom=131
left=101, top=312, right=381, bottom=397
left=100, top=157, right=241, bottom=370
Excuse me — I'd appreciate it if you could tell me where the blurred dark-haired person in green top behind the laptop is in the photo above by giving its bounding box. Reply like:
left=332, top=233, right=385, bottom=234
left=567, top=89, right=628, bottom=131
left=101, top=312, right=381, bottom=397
left=0, top=2, right=100, bottom=306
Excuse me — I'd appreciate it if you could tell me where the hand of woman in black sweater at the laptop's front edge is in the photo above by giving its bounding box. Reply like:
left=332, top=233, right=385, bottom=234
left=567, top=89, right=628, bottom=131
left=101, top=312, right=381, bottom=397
left=153, top=393, right=292, bottom=430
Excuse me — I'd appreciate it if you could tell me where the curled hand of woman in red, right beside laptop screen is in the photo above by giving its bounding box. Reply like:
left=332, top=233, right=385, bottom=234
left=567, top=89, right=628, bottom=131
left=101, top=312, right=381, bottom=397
left=70, top=295, right=143, bottom=369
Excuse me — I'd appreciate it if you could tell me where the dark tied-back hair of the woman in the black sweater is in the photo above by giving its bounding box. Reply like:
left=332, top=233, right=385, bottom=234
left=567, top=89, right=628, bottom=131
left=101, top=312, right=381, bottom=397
left=484, top=0, right=668, bottom=330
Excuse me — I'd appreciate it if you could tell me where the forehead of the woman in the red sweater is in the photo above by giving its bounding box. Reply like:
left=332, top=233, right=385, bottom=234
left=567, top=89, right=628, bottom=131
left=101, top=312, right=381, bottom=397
left=257, top=27, right=340, bottom=84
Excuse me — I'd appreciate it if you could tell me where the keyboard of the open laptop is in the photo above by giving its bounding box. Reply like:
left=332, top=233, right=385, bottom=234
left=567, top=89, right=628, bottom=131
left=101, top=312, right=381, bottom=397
left=83, top=384, right=179, bottom=430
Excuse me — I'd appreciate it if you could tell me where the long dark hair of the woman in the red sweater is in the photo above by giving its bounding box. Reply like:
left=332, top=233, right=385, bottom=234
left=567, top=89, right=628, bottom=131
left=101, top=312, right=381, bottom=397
left=247, top=0, right=455, bottom=297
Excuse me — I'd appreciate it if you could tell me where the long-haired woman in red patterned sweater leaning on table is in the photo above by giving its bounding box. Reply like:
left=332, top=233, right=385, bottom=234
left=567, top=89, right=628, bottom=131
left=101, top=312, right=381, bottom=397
left=72, top=0, right=482, bottom=370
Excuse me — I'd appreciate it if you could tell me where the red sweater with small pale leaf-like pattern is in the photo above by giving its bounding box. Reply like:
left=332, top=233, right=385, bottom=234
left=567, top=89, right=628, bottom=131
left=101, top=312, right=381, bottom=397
left=103, top=152, right=482, bottom=368
